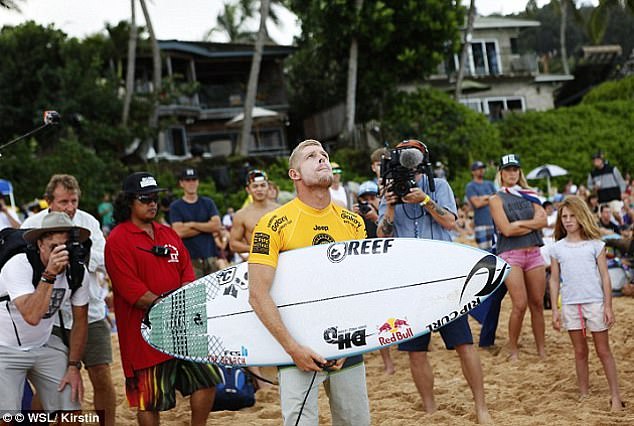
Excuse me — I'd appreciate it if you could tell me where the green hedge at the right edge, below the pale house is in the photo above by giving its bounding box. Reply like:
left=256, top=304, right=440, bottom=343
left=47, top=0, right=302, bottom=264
left=497, top=101, right=634, bottom=191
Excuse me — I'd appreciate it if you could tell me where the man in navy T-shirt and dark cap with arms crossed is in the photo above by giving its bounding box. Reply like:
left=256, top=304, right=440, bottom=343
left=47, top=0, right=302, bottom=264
left=170, top=167, right=220, bottom=278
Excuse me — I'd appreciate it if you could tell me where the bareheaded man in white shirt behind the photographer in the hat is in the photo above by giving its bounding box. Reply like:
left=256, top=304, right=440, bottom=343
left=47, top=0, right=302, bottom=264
left=22, top=174, right=117, bottom=425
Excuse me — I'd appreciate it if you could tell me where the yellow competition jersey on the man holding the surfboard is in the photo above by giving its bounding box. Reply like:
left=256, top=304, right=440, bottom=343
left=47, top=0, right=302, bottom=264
left=249, top=198, right=366, bottom=267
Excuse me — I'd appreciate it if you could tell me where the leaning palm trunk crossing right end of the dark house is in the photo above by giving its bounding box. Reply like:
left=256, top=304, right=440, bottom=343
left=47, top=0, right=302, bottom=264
left=237, top=0, right=270, bottom=156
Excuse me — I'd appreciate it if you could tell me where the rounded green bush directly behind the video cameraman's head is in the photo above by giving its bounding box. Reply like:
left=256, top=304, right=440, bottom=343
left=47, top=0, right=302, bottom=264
left=383, top=88, right=501, bottom=195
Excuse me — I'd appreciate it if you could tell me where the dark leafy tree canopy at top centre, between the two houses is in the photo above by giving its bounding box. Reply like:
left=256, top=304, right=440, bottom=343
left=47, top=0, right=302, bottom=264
left=289, top=0, right=465, bottom=121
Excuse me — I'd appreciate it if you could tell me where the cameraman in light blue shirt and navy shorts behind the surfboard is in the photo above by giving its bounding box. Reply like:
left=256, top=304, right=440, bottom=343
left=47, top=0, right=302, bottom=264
left=377, top=139, right=491, bottom=423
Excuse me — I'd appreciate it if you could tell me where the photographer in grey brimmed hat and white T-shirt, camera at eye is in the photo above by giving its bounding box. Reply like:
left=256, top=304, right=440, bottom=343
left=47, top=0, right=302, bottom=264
left=0, top=212, right=90, bottom=412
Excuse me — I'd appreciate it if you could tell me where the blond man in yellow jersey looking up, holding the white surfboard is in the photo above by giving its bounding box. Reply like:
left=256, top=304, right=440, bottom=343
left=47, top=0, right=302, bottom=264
left=249, top=139, right=370, bottom=425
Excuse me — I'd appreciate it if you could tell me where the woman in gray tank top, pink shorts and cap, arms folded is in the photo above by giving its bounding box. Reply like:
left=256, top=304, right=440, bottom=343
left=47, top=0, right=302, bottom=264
left=489, top=154, right=546, bottom=360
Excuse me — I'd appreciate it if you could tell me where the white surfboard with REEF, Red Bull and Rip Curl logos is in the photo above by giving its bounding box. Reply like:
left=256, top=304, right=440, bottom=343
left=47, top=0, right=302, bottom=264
left=141, top=238, right=510, bottom=366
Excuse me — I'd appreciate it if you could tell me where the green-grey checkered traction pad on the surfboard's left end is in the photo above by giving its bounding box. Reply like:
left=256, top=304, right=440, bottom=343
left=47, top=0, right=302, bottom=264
left=142, top=275, right=224, bottom=362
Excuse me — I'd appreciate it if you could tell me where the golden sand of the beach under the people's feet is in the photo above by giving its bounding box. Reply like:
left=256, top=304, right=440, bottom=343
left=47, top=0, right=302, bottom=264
left=83, top=296, right=634, bottom=426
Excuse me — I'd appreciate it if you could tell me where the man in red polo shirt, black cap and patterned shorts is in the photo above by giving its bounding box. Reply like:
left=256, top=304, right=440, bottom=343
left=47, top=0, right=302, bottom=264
left=105, top=172, right=220, bottom=425
